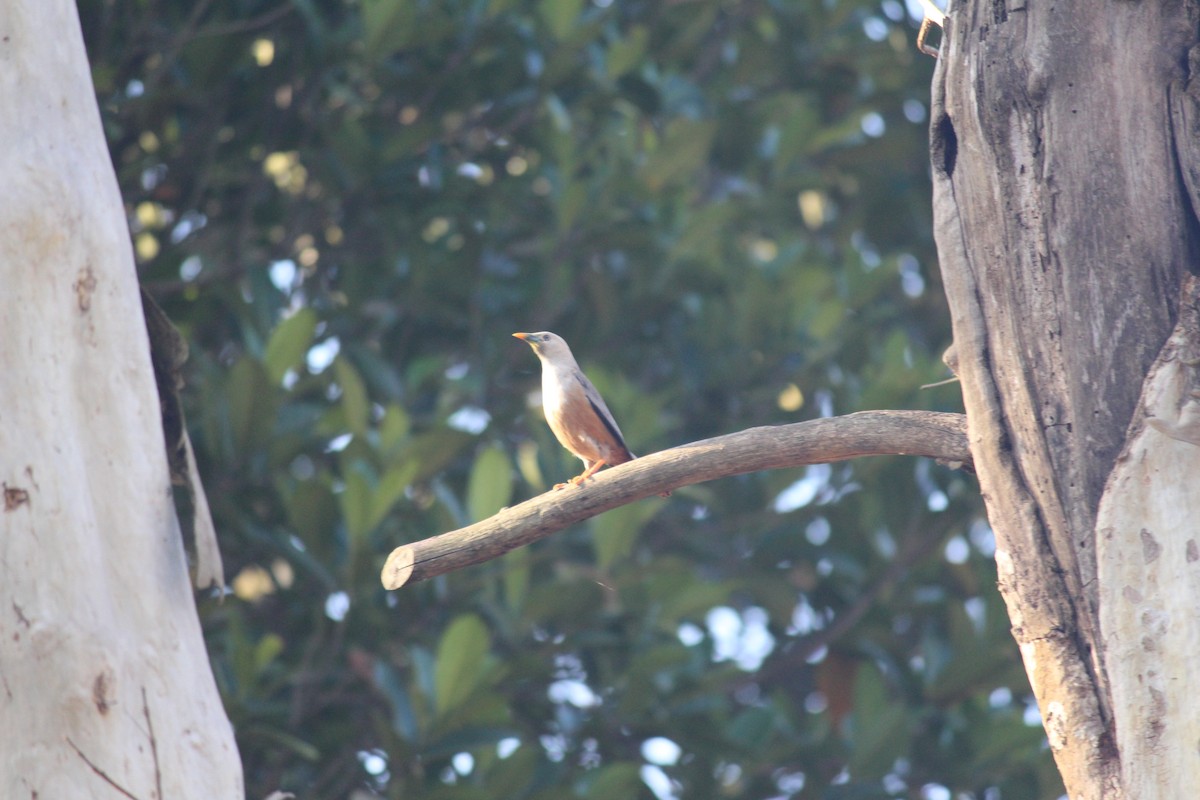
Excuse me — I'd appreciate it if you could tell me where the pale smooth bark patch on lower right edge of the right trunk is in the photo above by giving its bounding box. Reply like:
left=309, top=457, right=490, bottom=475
left=1096, top=277, right=1200, bottom=798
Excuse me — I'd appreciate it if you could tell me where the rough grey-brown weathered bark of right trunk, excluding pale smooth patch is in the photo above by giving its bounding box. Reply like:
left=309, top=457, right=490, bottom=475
left=931, top=0, right=1198, bottom=799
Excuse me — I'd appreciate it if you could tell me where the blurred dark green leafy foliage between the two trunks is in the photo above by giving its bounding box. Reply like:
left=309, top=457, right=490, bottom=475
left=79, top=0, right=1062, bottom=800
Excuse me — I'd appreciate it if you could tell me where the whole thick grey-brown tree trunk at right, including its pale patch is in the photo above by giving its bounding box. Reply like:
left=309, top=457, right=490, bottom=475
left=931, top=0, right=1200, bottom=800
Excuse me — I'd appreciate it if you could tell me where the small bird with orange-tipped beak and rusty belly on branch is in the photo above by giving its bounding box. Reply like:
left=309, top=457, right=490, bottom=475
left=512, top=331, right=636, bottom=489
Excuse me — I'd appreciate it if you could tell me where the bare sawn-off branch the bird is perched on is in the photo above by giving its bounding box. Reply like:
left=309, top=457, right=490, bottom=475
left=380, top=411, right=971, bottom=589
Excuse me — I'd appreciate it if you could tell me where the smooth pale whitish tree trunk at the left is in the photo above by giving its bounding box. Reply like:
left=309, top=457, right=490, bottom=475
left=0, top=0, right=242, bottom=800
